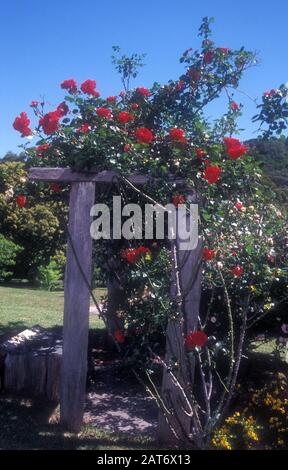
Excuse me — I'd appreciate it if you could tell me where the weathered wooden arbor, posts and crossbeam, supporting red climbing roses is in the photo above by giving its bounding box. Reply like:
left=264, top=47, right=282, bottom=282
left=29, top=168, right=201, bottom=440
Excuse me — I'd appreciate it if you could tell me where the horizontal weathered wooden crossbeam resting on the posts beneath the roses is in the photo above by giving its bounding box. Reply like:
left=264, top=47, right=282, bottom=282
left=28, top=167, right=185, bottom=186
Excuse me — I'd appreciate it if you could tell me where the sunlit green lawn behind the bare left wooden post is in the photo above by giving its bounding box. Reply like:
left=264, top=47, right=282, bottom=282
left=0, top=284, right=106, bottom=340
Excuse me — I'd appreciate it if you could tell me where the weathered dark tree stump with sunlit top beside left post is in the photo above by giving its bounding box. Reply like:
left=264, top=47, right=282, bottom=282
left=0, top=326, right=62, bottom=401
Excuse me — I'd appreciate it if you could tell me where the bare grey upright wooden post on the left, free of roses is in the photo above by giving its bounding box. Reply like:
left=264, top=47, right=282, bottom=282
left=60, top=182, right=95, bottom=432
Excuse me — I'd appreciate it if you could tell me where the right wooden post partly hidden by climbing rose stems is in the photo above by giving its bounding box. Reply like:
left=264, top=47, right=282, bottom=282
left=157, top=193, right=202, bottom=444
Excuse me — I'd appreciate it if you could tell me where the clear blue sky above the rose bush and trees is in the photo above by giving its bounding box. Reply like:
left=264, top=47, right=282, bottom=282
left=0, top=0, right=288, bottom=156
